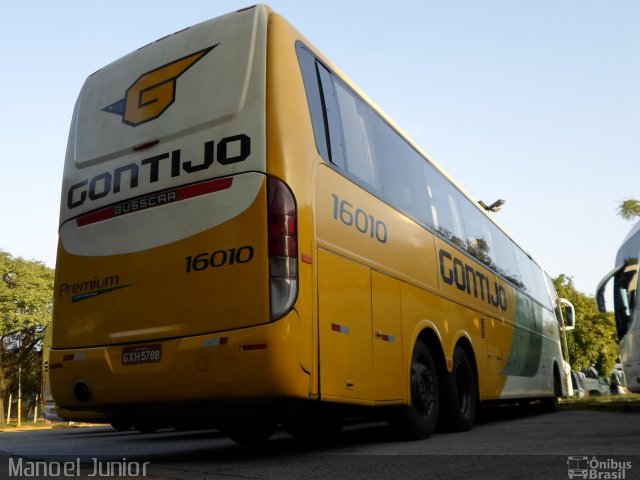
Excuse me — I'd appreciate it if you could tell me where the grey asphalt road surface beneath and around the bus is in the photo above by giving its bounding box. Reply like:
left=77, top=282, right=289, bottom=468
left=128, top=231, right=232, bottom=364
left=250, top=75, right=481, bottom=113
left=0, top=409, right=640, bottom=480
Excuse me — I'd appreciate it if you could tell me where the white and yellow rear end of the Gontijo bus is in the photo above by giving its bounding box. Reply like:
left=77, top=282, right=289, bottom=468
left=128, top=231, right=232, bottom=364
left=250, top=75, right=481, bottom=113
left=50, top=6, right=308, bottom=432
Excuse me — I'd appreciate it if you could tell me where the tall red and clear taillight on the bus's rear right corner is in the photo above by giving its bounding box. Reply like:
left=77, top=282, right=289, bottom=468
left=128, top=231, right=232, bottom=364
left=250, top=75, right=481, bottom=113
left=267, top=177, right=298, bottom=320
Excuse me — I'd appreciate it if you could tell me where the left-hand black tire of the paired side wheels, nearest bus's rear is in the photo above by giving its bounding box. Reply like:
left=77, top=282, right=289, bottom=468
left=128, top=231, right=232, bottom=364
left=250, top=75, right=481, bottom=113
left=389, top=342, right=440, bottom=440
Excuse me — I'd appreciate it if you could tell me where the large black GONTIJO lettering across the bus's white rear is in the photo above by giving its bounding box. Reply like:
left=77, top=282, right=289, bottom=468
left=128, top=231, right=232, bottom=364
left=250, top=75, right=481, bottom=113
left=67, top=133, right=251, bottom=209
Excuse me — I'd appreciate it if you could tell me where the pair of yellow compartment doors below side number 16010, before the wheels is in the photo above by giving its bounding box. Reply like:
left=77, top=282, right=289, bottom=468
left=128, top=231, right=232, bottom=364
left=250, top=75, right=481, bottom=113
left=318, top=250, right=405, bottom=402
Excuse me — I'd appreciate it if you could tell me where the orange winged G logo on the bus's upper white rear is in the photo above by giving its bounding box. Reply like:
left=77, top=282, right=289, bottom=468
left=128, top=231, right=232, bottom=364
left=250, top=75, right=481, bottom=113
left=102, top=44, right=219, bottom=127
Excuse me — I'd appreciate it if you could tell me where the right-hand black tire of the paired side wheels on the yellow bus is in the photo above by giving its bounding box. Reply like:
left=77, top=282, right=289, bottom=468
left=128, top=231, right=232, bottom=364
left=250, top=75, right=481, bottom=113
left=441, top=346, right=478, bottom=432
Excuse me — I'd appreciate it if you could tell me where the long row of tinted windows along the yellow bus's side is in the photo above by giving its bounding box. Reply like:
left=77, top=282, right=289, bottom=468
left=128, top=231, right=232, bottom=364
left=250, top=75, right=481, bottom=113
left=299, top=48, right=552, bottom=308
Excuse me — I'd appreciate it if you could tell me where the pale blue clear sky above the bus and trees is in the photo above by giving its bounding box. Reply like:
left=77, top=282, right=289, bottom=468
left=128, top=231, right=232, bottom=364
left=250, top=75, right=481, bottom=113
left=0, top=0, right=640, bottom=294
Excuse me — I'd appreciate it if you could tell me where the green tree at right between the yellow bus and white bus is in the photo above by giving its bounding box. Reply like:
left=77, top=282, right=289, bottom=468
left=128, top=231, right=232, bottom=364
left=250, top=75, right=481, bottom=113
left=553, top=275, right=618, bottom=378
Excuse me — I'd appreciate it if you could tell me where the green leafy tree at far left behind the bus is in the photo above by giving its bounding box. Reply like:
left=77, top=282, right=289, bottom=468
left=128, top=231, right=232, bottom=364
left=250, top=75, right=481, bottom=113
left=0, top=250, right=54, bottom=422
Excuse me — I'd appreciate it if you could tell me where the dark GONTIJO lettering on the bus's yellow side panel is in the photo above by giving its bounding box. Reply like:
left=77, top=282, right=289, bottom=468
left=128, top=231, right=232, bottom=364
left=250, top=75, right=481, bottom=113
left=438, top=249, right=507, bottom=312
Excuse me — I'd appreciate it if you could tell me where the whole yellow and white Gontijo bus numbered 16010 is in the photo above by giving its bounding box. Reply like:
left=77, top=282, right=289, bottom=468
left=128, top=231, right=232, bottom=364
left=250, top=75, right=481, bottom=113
left=50, top=5, right=566, bottom=441
